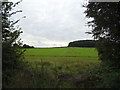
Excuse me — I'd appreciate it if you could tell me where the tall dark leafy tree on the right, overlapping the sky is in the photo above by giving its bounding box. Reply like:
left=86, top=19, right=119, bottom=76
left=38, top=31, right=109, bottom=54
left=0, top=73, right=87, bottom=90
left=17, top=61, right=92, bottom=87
left=85, top=2, right=120, bottom=68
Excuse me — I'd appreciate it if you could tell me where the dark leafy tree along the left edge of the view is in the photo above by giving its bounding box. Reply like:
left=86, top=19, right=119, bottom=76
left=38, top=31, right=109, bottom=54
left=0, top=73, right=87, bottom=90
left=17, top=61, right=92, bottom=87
left=0, top=2, right=24, bottom=88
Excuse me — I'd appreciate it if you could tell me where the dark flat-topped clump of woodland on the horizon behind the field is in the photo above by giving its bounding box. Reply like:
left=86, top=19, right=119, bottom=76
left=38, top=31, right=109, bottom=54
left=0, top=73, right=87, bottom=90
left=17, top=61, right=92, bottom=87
left=68, top=40, right=96, bottom=47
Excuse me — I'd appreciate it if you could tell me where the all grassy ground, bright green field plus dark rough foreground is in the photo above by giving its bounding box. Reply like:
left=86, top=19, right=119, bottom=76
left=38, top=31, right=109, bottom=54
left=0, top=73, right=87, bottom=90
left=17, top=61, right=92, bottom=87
left=7, top=48, right=120, bottom=88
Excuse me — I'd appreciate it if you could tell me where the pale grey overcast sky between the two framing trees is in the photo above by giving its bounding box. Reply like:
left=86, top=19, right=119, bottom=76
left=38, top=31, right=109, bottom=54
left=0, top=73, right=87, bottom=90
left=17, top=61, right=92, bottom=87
left=10, top=0, right=93, bottom=47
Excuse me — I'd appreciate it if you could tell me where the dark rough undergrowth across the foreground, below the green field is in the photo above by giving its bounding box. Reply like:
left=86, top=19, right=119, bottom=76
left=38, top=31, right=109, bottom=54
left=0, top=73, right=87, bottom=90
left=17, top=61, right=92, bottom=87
left=9, top=60, right=120, bottom=88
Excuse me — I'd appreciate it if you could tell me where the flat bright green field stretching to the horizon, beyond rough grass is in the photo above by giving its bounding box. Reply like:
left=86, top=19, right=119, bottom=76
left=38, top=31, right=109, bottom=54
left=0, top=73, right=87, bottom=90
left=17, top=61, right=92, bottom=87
left=25, top=48, right=98, bottom=63
